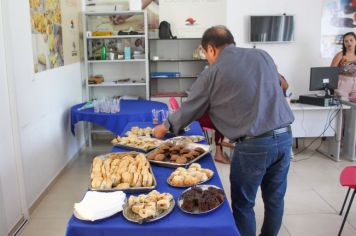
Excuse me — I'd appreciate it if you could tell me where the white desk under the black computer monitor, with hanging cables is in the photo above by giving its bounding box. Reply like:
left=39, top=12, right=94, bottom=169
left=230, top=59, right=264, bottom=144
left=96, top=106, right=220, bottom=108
left=291, top=103, right=349, bottom=161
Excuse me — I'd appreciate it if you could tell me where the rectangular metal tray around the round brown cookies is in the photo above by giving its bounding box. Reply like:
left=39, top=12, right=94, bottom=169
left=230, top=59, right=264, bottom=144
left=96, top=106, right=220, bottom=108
left=146, top=142, right=211, bottom=168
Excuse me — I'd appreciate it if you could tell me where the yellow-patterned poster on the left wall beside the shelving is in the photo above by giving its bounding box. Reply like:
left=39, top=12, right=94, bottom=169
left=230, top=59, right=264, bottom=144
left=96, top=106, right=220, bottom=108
left=29, top=0, right=80, bottom=73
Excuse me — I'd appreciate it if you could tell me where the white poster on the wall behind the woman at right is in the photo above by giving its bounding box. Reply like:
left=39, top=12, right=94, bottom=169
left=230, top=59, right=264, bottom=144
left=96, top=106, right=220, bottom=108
left=320, top=0, right=356, bottom=58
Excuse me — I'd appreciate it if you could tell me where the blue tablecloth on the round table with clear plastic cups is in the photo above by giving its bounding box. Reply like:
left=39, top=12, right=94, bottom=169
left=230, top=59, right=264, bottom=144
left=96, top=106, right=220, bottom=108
left=70, top=100, right=168, bottom=135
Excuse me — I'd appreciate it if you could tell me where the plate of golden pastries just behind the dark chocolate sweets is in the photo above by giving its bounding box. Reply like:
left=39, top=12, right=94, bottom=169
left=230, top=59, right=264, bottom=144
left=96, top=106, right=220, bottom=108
left=167, top=163, right=214, bottom=188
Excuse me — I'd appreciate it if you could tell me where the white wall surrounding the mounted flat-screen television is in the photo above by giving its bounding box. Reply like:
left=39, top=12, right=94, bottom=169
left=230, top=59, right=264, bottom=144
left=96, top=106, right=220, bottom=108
left=226, top=0, right=331, bottom=98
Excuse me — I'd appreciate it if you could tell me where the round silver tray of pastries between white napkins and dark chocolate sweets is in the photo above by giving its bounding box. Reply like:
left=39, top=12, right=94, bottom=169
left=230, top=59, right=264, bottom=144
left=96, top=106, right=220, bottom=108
left=122, top=190, right=175, bottom=224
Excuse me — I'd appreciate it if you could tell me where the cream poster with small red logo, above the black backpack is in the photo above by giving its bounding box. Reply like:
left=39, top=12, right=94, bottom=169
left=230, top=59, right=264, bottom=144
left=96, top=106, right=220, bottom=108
left=159, top=0, right=226, bottom=38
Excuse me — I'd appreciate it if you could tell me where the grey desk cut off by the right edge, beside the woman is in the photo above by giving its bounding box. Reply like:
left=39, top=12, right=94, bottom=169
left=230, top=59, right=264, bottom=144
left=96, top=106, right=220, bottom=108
left=341, top=100, right=356, bottom=161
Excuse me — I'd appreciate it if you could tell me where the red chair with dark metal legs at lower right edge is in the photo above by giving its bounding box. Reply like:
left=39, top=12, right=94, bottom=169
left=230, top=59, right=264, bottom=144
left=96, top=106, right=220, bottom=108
left=338, top=166, right=356, bottom=236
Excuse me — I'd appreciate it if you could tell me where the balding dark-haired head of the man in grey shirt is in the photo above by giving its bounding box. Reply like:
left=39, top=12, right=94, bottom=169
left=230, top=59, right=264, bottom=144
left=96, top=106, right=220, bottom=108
left=201, top=25, right=235, bottom=64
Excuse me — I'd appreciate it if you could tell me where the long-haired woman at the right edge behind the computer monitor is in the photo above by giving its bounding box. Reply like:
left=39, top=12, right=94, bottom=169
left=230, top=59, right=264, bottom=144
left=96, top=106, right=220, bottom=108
left=331, top=32, right=356, bottom=100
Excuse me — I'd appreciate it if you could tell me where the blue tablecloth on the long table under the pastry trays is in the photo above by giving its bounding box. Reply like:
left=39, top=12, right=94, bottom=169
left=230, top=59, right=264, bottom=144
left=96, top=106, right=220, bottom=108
left=67, top=122, right=240, bottom=236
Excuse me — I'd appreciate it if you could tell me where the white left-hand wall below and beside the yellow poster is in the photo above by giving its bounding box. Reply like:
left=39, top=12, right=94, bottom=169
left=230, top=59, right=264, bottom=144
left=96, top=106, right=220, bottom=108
left=4, top=0, right=84, bottom=216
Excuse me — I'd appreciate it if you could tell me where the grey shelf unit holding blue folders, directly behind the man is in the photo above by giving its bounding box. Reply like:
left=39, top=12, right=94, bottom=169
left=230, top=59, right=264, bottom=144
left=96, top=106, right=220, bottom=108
left=149, top=38, right=208, bottom=100
